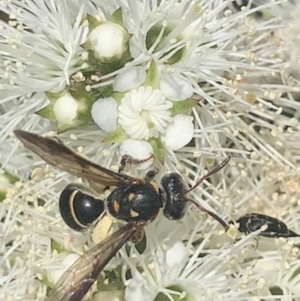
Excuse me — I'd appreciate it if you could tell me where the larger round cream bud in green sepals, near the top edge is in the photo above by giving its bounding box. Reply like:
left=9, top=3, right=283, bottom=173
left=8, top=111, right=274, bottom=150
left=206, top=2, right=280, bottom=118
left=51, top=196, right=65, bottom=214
left=88, top=21, right=128, bottom=62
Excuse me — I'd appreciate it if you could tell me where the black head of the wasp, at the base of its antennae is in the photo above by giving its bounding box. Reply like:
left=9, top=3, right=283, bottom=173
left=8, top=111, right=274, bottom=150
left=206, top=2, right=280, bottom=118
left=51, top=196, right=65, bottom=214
left=161, top=173, right=187, bottom=220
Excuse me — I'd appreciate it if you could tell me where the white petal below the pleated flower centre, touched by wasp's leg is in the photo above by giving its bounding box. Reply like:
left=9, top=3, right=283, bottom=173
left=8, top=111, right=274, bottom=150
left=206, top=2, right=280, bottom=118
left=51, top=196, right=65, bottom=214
left=119, top=139, right=153, bottom=169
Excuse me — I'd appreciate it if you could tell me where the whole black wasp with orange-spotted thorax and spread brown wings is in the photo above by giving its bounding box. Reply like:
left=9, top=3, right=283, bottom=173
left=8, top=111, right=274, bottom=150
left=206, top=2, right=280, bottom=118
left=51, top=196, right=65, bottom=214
left=15, top=130, right=230, bottom=301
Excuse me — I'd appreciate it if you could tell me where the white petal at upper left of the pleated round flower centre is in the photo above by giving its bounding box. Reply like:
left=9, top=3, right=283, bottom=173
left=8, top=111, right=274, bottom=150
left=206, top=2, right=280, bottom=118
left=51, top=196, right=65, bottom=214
left=113, top=67, right=146, bottom=92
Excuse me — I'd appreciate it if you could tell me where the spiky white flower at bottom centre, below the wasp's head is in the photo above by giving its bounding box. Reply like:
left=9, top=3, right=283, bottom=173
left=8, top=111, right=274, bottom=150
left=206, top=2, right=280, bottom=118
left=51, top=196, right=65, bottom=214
left=125, top=224, right=255, bottom=301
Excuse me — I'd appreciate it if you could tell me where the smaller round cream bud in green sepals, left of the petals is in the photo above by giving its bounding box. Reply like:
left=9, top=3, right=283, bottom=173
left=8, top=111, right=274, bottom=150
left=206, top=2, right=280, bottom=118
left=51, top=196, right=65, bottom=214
left=53, top=93, right=78, bottom=124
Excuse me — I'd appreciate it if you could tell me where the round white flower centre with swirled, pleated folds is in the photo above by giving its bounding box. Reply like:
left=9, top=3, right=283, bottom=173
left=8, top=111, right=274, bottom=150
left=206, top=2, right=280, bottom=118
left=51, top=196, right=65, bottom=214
left=118, top=86, right=172, bottom=140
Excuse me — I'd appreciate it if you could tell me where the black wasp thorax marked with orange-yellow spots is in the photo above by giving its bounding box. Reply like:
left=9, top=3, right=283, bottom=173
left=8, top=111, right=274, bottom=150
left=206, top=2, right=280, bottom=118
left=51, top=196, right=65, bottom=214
left=107, top=183, right=163, bottom=222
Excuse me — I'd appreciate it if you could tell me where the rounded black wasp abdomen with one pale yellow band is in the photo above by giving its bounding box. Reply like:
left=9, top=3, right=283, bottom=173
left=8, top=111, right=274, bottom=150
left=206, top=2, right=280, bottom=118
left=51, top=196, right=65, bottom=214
left=59, top=184, right=104, bottom=231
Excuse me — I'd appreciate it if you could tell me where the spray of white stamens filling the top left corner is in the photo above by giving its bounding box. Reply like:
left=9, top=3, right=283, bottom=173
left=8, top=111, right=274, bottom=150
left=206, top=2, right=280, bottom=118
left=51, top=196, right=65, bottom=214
left=0, top=1, right=88, bottom=95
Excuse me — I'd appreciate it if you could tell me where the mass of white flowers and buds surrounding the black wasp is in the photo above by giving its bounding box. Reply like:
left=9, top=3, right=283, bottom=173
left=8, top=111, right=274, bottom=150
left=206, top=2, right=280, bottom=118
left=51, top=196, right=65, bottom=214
left=0, top=0, right=300, bottom=301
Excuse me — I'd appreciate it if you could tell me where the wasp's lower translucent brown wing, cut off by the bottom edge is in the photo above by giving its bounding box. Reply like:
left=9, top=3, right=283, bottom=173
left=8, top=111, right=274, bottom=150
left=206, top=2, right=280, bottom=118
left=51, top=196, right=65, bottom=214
left=45, top=223, right=142, bottom=301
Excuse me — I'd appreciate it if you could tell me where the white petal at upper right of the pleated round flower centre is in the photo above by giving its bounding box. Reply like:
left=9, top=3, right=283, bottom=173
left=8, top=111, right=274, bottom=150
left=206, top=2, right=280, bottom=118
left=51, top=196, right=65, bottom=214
left=160, top=73, right=193, bottom=100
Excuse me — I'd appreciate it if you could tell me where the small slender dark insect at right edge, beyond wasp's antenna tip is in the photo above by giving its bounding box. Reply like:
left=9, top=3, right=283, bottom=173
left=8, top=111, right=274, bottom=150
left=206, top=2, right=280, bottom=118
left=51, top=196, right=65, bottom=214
left=236, top=213, right=300, bottom=238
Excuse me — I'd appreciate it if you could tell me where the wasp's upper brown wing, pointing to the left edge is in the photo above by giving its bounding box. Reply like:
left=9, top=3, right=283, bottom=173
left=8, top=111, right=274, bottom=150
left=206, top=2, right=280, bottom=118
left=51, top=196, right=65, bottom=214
left=14, top=130, right=140, bottom=186
